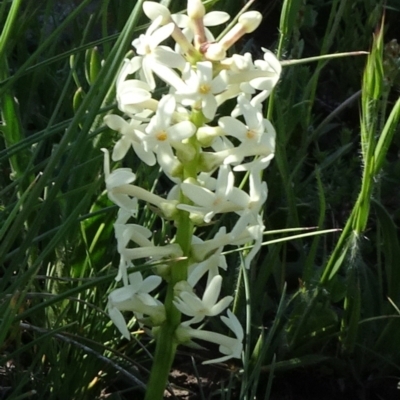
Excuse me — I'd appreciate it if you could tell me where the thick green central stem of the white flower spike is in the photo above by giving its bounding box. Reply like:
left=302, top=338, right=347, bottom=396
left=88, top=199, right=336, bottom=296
left=145, top=111, right=204, bottom=400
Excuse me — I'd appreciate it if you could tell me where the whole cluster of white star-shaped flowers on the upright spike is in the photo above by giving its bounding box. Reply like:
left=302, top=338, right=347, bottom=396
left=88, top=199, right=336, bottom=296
left=104, top=0, right=281, bottom=362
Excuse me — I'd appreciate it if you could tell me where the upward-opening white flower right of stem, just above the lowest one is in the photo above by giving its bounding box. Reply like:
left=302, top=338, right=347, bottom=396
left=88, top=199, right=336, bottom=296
left=174, top=275, right=233, bottom=325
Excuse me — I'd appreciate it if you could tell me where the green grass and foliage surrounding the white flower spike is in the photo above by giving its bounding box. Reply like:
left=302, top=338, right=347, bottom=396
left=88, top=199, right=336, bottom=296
left=0, top=0, right=400, bottom=399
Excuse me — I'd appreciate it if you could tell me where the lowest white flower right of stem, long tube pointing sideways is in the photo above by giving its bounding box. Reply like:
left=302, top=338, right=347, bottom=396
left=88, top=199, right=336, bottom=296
left=176, top=310, right=244, bottom=364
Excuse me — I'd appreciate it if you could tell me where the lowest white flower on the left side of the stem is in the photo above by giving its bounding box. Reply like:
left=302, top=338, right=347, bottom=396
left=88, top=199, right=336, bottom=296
left=107, top=272, right=165, bottom=340
